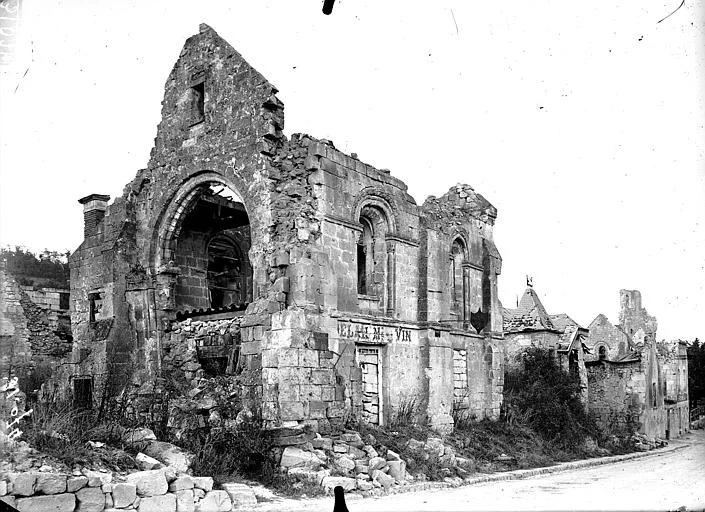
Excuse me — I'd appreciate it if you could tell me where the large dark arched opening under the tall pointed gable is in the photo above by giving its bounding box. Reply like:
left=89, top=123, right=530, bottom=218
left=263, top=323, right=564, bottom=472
left=174, top=183, right=252, bottom=313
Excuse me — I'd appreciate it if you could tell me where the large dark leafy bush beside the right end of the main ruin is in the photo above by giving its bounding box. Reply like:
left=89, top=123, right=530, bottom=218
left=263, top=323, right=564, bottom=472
left=503, top=347, right=599, bottom=450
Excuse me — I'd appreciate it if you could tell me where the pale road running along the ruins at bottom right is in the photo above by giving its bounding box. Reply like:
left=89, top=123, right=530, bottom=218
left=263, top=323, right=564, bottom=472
left=258, top=430, right=705, bottom=512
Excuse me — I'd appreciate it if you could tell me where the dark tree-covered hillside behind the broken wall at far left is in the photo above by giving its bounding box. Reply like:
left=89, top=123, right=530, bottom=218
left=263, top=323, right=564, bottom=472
left=0, top=246, right=69, bottom=288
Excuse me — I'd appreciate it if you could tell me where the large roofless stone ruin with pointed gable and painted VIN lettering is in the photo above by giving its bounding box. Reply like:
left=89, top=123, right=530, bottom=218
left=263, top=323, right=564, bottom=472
left=63, top=25, right=506, bottom=430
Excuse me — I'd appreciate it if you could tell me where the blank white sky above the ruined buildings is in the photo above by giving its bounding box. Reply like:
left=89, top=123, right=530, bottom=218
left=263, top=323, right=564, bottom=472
left=0, top=0, right=705, bottom=339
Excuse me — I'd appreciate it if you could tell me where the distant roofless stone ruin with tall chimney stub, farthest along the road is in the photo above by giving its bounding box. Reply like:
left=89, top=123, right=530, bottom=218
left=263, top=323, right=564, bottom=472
left=586, top=290, right=689, bottom=439
